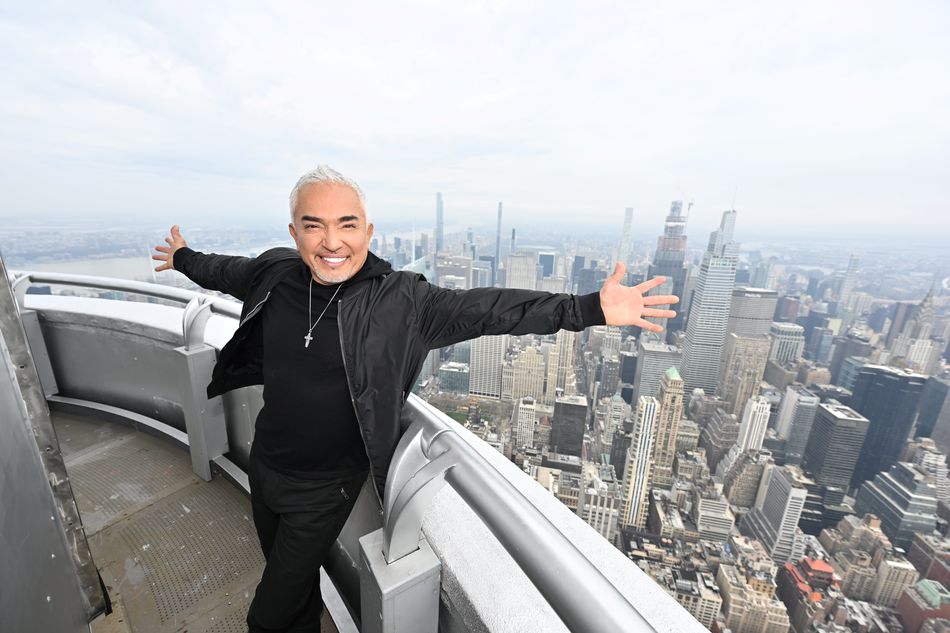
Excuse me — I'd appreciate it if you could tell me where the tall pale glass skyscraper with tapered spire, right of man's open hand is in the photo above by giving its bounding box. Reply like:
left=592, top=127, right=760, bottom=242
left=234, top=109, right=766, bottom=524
left=680, top=211, right=739, bottom=393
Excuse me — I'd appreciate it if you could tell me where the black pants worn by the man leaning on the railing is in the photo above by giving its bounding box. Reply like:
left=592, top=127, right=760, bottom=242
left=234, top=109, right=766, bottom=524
left=247, top=450, right=367, bottom=633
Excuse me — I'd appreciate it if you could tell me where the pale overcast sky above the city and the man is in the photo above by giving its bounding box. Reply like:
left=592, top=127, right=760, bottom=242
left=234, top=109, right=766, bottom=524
left=0, top=0, right=950, bottom=239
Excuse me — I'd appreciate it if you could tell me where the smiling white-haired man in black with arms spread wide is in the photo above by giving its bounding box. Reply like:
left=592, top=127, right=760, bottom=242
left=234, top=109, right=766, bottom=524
left=153, top=166, right=677, bottom=632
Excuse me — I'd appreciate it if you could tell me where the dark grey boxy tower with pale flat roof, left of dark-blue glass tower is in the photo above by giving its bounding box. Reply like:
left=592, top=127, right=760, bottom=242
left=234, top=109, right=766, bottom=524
left=802, top=400, right=869, bottom=490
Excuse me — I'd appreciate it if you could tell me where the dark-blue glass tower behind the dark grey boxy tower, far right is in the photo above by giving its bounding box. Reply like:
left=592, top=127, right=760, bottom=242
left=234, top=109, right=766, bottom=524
left=849, top=365, right=927, bottom=488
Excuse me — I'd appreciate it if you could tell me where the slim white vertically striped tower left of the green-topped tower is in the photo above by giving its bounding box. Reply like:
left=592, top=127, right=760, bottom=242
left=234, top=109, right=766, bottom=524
left=620, top=396, right=660, bottom=529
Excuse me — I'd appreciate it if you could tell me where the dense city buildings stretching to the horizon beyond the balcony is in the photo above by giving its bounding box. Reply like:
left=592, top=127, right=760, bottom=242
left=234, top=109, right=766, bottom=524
left=7, top=185, right=950, bottom=633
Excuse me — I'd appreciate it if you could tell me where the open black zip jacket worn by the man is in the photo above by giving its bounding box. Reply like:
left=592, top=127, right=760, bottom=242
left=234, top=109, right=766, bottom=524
left=174, top=247, right=604, bottom=499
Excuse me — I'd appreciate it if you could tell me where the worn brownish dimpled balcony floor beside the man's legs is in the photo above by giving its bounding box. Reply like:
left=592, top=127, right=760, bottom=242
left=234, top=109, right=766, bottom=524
left=53, top=413, right=337, bottom=633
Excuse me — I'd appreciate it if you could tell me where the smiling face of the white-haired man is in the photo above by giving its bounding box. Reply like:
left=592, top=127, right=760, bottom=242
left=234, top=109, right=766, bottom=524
left=290, top=183, right=373, bottom=285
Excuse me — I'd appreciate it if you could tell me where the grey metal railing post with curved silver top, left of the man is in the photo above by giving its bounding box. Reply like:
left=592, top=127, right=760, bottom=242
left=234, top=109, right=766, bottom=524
left=175, top=297, right=228, bottom=481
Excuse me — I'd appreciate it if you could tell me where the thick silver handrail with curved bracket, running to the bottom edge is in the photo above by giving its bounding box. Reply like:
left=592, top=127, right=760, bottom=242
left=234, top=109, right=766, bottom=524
left=383, top=395, right=654, bottom=633
